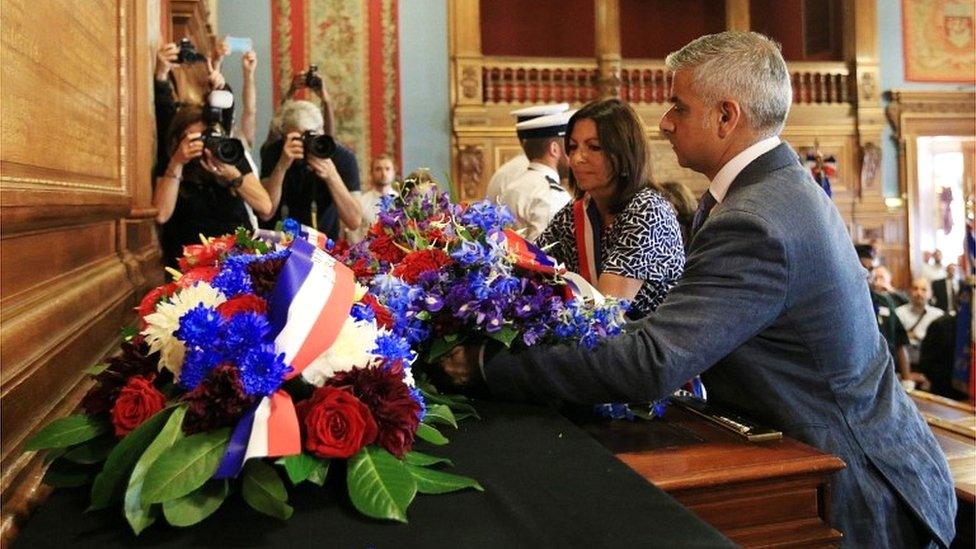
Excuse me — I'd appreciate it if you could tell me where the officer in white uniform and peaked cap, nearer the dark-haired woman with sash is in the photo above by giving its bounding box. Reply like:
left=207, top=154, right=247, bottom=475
left=498, top=111, right=575, bottom=242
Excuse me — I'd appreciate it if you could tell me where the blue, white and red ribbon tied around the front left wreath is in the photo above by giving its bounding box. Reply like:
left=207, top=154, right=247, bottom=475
left=214, top=239, right=355, bottom=478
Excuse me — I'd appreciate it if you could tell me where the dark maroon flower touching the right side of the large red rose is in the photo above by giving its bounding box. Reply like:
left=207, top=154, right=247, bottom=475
left=326, top=364, right=420, bottom=458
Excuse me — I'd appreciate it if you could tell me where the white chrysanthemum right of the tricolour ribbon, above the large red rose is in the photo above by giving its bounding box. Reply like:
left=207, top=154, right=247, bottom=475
left=302, top=317, right=379, bottom=387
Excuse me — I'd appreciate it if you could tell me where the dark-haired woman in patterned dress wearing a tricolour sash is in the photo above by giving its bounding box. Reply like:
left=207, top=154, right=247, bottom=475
left=537, top=99, right=685, bottom=318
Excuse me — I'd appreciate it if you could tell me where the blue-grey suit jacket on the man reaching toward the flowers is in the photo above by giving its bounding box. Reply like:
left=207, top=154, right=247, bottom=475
left=485, top=143, right=956, bottom=547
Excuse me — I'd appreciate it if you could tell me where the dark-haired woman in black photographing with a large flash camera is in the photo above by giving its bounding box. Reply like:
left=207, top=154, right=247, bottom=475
left=153, top=105, right=274, bottom=266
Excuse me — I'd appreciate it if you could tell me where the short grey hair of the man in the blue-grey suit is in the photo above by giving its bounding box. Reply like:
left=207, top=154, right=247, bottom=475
left=664, top=31, right=793, bottom=137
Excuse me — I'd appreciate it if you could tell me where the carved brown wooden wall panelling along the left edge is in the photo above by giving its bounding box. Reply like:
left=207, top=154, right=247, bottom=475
left=0, top=0, right=163, bottom=545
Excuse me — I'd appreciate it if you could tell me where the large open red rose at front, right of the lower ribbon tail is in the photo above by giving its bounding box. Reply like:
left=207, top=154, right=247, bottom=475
left=296, top=387, right=377, bottom=458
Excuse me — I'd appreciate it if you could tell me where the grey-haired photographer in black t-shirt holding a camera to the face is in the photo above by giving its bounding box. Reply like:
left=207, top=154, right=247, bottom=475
left=261, top=101, right=362, bottom=240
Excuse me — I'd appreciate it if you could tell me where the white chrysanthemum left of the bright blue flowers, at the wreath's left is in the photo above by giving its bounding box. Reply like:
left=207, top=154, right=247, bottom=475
left=142, top=282, right=227, bottom=380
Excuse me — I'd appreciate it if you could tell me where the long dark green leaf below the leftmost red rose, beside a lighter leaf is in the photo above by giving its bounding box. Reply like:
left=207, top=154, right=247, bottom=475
left=89, top=408, right=173, bottom=510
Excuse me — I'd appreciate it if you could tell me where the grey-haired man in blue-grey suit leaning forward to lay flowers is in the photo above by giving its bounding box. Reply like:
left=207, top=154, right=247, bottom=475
left=441, top=31, right=956, bottom=547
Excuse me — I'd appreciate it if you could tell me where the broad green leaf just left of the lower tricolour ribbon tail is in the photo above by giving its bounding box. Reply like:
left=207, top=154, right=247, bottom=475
left=142, top=427, right=230, bottom=503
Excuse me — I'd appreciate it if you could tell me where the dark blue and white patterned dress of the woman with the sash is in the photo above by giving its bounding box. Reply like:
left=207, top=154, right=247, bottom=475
left=536, top=188, right=685, bottom=319
